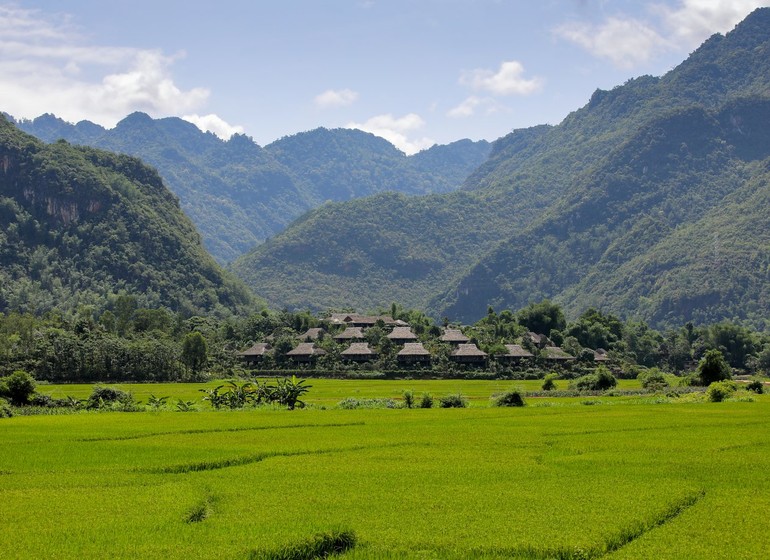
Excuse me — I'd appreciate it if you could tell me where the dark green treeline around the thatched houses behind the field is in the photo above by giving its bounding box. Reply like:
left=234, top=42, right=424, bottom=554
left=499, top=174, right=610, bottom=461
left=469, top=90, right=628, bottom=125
left=0, top=295, right=770, bottom=382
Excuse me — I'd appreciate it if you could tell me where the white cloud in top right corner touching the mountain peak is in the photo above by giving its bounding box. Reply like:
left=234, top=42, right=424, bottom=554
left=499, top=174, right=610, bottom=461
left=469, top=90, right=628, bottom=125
left=652, top=0, right=770, bottom=47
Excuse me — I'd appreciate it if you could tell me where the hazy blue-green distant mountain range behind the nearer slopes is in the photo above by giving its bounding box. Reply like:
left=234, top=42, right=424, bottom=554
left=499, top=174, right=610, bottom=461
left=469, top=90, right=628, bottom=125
left=17, top=113, right=491, bottom=263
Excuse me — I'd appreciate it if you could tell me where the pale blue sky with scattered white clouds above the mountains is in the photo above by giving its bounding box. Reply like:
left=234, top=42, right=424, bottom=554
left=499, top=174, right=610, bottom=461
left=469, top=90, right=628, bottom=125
left=0, top=0, right=770, bottom=154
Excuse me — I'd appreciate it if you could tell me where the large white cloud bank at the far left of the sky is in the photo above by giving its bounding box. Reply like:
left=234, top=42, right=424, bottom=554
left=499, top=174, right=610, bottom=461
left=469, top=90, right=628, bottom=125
left=0, top=5, right=226, bottom=126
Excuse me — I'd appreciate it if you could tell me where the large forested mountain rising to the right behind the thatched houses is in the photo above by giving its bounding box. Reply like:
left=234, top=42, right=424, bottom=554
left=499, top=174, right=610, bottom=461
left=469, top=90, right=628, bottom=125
left=235, top=9, right=770, bottom=326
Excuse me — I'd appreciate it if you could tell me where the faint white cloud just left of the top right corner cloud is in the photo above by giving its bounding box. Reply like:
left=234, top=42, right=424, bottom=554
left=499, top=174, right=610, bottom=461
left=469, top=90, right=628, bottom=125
left=554, top=17, right=671, bottom=69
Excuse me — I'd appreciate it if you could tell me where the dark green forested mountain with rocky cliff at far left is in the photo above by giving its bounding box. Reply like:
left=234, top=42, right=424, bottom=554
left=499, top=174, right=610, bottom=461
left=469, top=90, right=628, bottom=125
left=0, top=115, right=255, bottom=315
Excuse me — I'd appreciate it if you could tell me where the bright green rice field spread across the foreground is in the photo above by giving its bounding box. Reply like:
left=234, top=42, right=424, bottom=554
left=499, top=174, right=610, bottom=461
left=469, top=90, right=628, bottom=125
left=0, top=380, right=770, bottom=559
